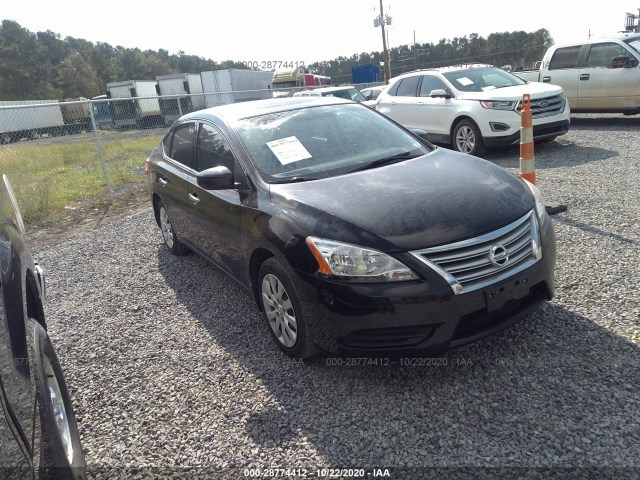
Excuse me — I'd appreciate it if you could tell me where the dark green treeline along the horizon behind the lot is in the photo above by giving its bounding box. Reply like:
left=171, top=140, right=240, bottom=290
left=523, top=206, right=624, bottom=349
left=0, top=20, right=553, bottom=100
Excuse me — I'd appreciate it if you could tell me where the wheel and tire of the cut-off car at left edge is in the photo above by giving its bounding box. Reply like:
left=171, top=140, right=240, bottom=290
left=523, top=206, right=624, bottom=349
left=27, top=319, right=87, bottom=480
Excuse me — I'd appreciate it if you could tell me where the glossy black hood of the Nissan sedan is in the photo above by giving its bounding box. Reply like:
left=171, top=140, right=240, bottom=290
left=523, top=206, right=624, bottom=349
left=270, top=148, right=534, bottom=252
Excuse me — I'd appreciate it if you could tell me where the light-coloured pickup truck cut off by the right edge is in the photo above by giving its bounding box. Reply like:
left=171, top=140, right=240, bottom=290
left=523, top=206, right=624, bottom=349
left=512, top=33, right=640, bottom=115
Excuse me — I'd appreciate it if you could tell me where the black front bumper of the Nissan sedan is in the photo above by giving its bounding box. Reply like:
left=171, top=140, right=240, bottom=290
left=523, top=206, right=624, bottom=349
left=297, top=220, right=556, bottom=357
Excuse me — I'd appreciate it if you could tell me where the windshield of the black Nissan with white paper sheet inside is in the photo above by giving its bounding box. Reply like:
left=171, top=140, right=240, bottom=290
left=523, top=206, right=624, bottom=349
left=235, top=104, right=431, bottom=183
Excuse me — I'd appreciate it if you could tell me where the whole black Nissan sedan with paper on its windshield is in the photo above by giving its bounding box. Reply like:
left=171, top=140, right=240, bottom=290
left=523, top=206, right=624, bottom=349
left=147, top=98, right=556, bottom=358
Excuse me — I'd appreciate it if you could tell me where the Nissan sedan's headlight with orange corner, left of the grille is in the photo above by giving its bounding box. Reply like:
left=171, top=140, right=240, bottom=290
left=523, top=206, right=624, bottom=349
left=307, top=237, right=419, bottom=282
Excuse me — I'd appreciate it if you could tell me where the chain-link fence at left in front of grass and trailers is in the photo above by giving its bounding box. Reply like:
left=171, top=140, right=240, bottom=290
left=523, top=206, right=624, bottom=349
left=0, top=85, right=378, bottom=228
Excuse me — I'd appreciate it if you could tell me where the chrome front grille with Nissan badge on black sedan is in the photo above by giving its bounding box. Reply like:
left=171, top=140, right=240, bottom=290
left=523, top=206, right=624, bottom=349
left=411, top=210, right=542, bottom=295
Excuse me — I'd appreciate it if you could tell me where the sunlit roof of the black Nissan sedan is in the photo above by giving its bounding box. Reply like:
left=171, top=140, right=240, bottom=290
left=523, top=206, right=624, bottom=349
left=182, top=97, right=355, bottom=122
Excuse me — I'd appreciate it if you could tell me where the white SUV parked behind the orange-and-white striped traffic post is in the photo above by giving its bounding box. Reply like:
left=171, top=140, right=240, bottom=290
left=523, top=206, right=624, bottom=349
left=375, top=65, right=570, bottom=155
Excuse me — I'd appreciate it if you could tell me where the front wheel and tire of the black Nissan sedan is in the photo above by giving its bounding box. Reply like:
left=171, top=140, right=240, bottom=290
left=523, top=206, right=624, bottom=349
left=258, top=257, right=316, bottom=358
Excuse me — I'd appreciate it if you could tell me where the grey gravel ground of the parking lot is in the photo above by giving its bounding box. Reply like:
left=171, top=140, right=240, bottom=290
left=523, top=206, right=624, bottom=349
left=35, top=115, right=640, bottom=478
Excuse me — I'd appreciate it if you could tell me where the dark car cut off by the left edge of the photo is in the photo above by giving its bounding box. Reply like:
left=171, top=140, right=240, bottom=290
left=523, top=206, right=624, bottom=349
left=0, top=175, right=86, bottom=479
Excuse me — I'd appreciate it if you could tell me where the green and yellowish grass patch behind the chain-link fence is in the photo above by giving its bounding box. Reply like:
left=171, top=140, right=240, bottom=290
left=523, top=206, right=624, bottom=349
left=0, top=132, right=164, bottom=225
